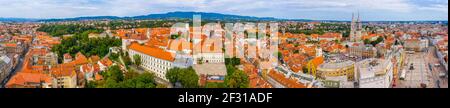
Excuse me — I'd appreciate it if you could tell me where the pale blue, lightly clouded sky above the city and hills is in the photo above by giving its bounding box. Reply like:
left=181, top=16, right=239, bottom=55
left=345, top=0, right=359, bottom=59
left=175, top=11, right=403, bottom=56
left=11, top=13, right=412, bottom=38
left=0, top=0, right=448, bottom=21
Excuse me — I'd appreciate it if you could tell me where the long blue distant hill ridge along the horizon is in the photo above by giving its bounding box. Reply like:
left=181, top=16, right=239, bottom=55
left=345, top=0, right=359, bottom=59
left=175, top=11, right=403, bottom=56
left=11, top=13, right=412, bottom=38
left=0, top=12, right=312, bottom=22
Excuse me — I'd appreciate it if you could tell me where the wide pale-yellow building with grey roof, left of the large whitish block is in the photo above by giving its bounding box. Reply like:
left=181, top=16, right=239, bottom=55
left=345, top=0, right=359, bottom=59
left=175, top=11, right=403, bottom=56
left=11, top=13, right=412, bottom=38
left=317, top=61, right=355, bottom=81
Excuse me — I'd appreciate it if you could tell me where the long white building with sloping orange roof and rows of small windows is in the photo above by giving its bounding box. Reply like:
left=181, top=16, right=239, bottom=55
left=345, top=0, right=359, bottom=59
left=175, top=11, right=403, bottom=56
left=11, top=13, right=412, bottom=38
left=128, top=43, right=175, bottom=81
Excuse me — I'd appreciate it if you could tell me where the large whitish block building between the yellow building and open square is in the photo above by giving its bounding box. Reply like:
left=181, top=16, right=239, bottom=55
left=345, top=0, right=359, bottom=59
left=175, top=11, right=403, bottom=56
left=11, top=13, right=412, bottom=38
left=356, top=58, right=393, bottom=88
